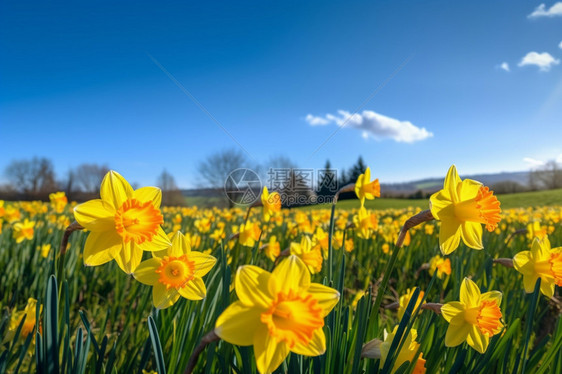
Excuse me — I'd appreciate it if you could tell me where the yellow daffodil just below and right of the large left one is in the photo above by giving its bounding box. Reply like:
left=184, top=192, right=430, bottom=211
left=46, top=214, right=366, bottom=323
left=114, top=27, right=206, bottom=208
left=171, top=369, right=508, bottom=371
left=133, top=231, right=217, bottom=309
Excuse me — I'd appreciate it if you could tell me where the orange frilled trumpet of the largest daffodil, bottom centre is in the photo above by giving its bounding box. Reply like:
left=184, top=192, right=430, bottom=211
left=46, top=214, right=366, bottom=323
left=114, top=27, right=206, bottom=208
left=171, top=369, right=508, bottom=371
left=261, top=290, right=324, bottom=348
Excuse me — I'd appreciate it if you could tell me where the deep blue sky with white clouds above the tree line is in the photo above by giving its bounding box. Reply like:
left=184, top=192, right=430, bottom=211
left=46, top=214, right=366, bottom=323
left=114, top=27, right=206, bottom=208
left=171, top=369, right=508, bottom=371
left=0, top=0, right=562, bottom=187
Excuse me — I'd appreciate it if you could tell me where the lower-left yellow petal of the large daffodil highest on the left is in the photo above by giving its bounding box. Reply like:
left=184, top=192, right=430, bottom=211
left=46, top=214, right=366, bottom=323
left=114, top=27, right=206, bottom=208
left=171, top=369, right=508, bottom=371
left=84, top=232, right=123, bottom=266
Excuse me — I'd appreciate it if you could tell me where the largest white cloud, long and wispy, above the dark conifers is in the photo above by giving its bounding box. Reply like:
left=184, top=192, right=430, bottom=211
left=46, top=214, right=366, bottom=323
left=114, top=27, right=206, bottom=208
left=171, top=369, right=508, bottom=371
left=306, top=110, right=433, bottom=143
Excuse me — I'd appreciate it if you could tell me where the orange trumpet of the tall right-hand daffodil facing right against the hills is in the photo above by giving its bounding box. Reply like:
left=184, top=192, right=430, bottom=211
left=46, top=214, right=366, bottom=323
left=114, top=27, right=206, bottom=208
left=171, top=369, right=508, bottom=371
left=454, top=186, right=501, bottom=232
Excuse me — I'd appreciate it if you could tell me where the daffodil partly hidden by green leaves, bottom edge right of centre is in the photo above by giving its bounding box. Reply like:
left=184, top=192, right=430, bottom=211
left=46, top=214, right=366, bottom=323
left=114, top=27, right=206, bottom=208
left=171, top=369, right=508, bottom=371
left=361, top=326, right=426, bottom=374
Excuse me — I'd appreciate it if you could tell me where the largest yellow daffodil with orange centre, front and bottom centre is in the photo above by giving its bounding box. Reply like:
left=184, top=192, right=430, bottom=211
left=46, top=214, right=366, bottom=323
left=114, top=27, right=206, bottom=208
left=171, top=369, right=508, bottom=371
left=215, top=256, right=340, bottom=373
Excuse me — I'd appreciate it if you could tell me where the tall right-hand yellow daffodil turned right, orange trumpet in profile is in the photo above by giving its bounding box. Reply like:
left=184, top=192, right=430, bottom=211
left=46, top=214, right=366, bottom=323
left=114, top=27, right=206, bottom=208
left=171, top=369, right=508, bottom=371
left=429, top=165, right=501, bottom=255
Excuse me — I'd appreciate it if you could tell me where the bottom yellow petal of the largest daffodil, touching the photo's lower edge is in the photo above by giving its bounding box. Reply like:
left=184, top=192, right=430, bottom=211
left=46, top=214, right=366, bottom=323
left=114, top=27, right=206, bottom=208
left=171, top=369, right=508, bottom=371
left=254, top=324, right=289, bottom=374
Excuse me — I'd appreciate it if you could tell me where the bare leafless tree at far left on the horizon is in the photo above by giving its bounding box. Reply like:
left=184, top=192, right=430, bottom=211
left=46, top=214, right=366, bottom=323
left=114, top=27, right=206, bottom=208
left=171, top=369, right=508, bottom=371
left=5, top=157, right=57, bottom=198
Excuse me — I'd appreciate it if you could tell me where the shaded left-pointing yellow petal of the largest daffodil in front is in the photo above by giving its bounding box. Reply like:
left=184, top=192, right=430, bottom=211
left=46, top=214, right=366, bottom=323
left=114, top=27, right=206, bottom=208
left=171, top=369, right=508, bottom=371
left=215, top=301, right=263, bottom=346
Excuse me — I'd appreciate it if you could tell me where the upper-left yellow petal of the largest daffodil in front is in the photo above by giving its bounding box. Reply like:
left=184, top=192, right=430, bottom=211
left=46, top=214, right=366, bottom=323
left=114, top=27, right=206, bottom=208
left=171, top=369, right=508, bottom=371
left=234, top=265, right=277, bottom=310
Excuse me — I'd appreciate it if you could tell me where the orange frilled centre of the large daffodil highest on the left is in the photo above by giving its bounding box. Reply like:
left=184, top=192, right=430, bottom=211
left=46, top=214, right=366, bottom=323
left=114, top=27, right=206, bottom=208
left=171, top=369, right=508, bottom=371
left=115, top=199, right=164, bottom=244
